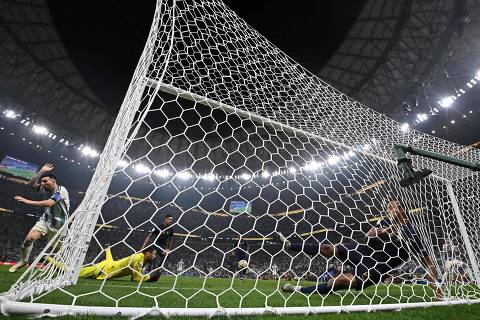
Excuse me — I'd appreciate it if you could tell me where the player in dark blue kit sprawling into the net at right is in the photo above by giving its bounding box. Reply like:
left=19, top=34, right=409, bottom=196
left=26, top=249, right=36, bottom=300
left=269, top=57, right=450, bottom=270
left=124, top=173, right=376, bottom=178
left=278, top=201, right=441, bottom=297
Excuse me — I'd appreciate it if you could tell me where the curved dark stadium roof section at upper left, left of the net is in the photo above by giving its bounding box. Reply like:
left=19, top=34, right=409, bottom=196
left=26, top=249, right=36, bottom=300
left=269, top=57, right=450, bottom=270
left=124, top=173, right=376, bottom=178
left=0, top=0, right=114, bottom=145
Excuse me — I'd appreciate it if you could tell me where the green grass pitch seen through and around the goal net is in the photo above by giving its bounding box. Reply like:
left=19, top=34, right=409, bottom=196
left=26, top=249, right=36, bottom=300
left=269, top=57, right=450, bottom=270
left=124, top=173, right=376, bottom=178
left=0, top=266, right=480, bottom=320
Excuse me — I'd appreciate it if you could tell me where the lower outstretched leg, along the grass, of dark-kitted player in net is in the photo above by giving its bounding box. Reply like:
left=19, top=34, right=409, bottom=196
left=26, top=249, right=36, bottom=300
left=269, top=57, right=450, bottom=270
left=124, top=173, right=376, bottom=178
left=282, top=273, right=358, bottom=294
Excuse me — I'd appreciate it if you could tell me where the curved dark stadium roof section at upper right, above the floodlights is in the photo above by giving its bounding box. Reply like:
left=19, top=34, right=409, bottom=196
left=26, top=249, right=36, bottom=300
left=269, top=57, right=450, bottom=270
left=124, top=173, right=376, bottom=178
left=318, top=0, right=480, bottom=119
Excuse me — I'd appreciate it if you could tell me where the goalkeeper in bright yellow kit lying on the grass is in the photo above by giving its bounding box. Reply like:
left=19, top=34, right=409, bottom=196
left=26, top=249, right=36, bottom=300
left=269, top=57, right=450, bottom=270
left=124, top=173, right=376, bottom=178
left=47, top=246, right=160, bottom=282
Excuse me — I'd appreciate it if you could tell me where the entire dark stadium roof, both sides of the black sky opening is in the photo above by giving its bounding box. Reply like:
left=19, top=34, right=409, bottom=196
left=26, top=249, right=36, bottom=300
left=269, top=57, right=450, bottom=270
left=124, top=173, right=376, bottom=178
left=0, top=0, right=480, bottom=147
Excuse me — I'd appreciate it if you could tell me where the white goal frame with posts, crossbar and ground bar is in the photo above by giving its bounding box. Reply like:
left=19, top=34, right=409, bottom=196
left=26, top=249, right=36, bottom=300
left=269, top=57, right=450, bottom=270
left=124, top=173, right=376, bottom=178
left=0, top=0, right=480, bottom=317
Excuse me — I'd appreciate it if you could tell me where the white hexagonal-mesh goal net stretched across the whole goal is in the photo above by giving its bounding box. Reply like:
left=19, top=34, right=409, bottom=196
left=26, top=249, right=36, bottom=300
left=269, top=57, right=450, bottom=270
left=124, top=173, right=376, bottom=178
left=0, top=0, right=480, bottom=316
